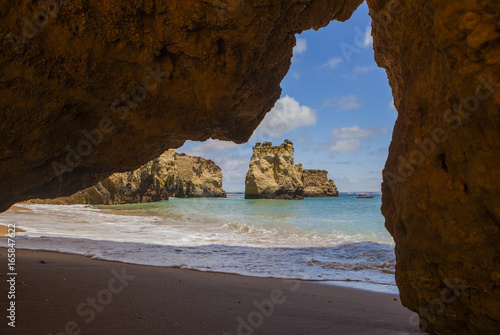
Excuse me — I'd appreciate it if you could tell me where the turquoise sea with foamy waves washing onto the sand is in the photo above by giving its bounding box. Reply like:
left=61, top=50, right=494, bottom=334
left=0, top=195, right=397, bottom=293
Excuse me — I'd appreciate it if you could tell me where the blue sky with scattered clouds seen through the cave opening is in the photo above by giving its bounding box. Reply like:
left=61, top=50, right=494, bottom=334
left=177, top=4, right=397, bottom=192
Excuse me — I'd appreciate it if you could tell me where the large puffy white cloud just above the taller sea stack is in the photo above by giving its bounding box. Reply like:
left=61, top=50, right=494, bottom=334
left=253, top=95, right=317, bottom=138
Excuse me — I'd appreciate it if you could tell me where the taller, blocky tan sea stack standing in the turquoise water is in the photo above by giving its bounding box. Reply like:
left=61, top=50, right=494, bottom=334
left=245, top=140, right=304, bottom=199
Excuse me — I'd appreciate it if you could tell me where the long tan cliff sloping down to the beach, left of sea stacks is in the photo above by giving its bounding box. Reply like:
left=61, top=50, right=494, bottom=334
left=28, top=150, right=226, bottom=205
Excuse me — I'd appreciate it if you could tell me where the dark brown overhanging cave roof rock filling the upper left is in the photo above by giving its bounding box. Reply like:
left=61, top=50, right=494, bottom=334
left=0, top=0, right=362, bottom=211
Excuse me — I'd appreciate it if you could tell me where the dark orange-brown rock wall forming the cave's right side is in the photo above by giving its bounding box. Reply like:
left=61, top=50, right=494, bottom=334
left=368, top=0, right=500, bottom=334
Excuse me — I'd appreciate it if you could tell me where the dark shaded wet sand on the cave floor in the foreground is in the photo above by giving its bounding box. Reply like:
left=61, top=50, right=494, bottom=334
left=0, top=249, right=418, bottom=335
